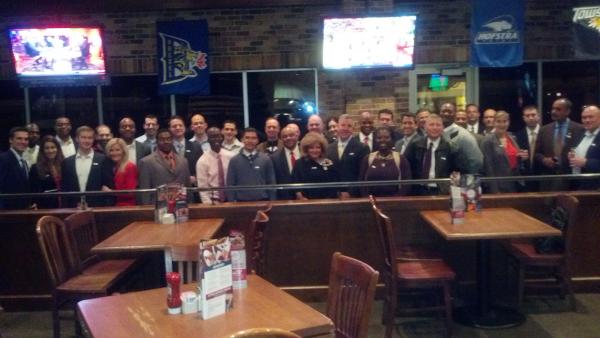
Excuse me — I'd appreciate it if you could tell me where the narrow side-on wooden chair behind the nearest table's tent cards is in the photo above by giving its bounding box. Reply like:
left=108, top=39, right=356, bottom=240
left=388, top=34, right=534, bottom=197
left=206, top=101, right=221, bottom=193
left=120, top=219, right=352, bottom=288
left=246, top=205, right=271, bottom=276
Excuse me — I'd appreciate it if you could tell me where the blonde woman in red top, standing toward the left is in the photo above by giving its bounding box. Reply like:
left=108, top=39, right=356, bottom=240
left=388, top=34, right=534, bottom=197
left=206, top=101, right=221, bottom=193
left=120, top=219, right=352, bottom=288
left=102, top=138, right=138, bottom=206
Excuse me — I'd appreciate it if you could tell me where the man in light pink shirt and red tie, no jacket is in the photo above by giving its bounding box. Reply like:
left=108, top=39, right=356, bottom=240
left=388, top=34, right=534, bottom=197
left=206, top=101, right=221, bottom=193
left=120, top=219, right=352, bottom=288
left=196, top=127, right=232, bottom=204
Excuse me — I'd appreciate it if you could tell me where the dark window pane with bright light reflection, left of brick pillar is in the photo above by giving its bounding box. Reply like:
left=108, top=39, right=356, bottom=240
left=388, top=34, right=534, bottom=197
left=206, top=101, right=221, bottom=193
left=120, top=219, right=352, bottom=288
left=248, top=70, right=316, bottom=134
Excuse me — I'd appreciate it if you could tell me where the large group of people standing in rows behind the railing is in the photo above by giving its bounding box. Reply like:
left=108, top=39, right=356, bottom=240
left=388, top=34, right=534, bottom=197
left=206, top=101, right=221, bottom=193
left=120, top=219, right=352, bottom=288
left=0, top=98, right=600, bottom=209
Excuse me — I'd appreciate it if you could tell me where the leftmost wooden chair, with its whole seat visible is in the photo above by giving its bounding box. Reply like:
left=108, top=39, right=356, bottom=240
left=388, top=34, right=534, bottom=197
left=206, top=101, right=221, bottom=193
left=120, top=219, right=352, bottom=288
left=36, top=216, right=134, bottom=338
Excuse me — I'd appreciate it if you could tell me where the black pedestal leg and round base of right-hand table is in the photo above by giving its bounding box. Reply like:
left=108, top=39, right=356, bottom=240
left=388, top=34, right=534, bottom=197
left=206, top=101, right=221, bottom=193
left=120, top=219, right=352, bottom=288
left=454, top=239, right=525, bottom=329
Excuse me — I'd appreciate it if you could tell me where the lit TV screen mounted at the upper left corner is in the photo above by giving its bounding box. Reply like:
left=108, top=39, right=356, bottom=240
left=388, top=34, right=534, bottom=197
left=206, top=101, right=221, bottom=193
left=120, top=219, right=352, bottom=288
left=9, top=27, right=106, bottom=78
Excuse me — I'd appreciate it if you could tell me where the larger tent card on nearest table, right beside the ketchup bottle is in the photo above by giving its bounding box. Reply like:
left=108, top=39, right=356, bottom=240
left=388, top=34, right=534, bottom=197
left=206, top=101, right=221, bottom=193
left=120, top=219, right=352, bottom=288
left=198, top=237, right=233, bottom=319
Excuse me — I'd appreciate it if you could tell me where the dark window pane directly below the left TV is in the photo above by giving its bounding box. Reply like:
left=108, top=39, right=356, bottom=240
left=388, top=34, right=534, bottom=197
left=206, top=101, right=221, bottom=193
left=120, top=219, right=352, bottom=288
left=29, top=87, right=98, bottom=134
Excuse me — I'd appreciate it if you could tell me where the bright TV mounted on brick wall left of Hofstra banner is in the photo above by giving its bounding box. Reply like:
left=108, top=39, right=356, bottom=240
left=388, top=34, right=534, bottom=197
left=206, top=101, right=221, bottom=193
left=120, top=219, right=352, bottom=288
left=323, top=15, right=417, bottom=69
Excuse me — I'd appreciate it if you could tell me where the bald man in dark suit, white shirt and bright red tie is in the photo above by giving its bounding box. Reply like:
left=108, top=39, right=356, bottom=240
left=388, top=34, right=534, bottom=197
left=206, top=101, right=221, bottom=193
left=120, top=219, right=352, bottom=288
left=271, top=123, right=302, bottom=200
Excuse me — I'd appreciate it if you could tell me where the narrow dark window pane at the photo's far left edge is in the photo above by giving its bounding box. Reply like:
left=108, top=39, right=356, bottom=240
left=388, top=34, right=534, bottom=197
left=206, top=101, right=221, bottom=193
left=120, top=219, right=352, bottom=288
left=0, top=80, right=25, bottom=150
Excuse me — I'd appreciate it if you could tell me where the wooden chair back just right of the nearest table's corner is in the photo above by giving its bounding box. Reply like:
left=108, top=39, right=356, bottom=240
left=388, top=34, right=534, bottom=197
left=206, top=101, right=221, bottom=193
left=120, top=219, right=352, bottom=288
left=327, top=252, right=379, bottom=338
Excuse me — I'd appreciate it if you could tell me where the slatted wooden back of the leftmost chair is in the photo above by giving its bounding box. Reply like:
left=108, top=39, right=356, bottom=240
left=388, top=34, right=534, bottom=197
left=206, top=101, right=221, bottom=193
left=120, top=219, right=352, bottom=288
left=36, top=216, right=74, bottom=287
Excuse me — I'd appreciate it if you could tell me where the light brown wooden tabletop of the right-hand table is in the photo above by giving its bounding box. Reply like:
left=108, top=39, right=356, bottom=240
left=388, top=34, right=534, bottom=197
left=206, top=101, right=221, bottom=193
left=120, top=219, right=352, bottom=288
left=420, top=208, right=561, bottom=241
